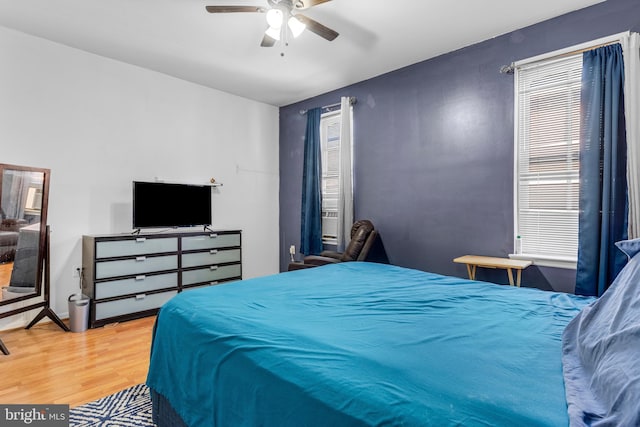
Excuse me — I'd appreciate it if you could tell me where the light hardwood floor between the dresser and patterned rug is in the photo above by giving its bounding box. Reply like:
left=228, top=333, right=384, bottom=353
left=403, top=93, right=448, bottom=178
left=0, top=317, right=155, bottom=407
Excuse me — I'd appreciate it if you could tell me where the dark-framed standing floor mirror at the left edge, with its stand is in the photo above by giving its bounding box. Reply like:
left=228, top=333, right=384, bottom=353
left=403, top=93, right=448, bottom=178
left=0, top=164, right=67, bottom=354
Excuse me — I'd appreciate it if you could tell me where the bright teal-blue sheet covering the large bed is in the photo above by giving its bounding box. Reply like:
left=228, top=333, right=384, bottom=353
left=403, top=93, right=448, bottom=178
left=147, top=249, right=640, bottom=427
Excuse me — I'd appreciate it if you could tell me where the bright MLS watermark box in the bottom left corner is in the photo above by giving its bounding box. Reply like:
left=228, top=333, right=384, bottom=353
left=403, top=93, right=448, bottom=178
left=0, top=405, right=69, bottom=427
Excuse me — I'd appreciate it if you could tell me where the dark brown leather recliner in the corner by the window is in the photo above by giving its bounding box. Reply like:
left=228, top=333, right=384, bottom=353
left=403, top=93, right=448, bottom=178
left=288, top=219, right=378, bottom=271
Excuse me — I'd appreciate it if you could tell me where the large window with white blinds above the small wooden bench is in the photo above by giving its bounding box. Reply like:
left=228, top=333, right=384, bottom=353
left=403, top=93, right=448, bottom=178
left=514, top=53, right=582, bottom=267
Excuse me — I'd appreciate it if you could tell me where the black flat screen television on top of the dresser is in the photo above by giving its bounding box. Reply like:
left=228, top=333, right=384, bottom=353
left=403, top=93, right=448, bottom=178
left=133, top=181, right=211, bottom=229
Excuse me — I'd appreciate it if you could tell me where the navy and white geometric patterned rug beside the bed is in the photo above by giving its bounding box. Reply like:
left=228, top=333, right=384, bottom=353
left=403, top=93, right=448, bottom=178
left=69, top=384, right=154, bottom=427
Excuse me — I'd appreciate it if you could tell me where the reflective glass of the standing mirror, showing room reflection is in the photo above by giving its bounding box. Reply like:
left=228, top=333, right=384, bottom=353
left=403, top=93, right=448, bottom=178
left=0, top=165, right=46, bottom=305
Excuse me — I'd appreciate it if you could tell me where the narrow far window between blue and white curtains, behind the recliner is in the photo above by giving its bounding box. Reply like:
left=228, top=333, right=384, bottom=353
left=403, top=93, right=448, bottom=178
left=320, top=110, right=341, bottom=245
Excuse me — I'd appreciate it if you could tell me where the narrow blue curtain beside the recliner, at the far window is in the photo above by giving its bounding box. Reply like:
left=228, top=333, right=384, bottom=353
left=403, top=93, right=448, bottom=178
left=300, top=108, right=322, bottom=255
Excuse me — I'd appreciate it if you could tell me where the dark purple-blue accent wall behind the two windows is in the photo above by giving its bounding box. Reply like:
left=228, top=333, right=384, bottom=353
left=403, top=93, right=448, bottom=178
left=280, top=0, right=640, bottom=292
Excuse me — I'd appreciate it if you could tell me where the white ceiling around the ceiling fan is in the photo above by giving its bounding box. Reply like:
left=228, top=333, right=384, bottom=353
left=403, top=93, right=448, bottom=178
left=0, top=0, right=603, bottom=106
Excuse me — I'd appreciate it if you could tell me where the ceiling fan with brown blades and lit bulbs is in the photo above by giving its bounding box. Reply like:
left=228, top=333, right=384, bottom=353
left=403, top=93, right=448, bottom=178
left=206, top=0, right=338, bottom=47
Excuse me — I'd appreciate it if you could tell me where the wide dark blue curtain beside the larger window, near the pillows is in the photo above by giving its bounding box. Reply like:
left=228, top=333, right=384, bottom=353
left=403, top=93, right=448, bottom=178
left=576, top=44, right=628, bottom=296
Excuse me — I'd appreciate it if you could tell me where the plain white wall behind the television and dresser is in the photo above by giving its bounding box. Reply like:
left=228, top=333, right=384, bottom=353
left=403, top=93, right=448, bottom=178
left=0, top=27, right=278, bottom=326
